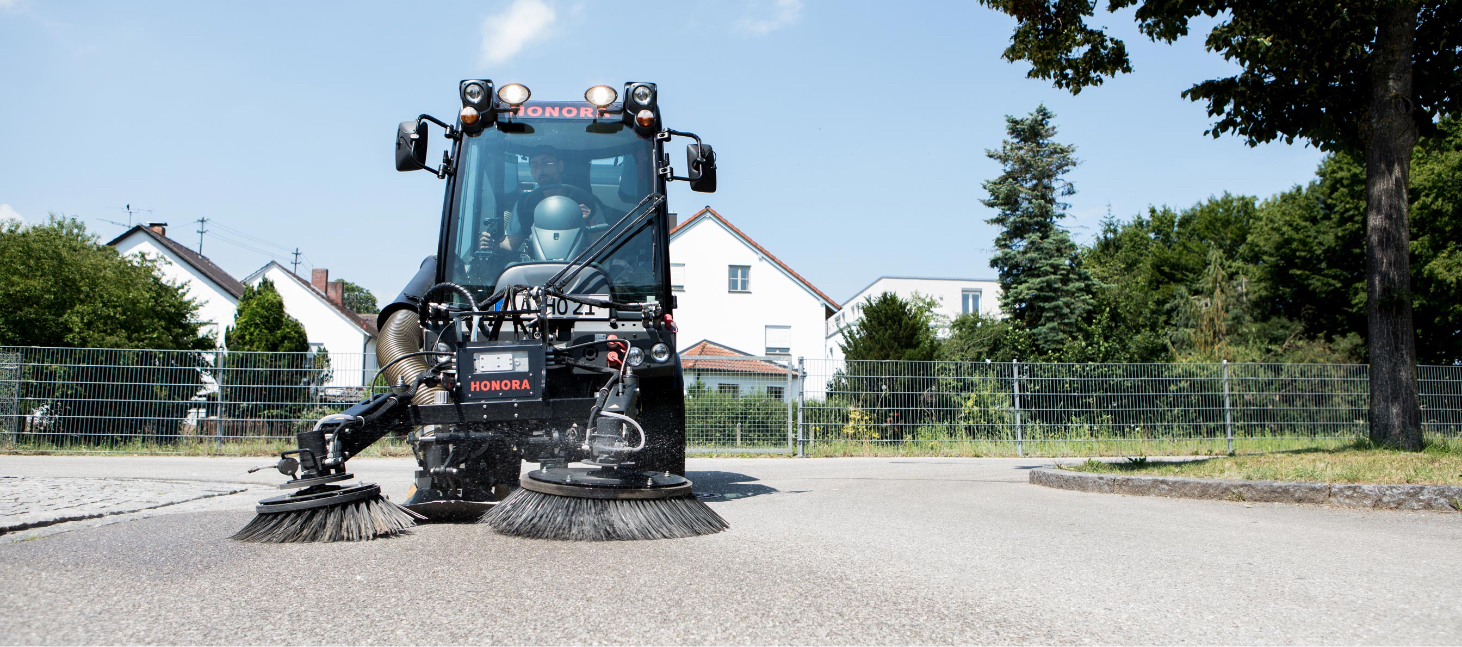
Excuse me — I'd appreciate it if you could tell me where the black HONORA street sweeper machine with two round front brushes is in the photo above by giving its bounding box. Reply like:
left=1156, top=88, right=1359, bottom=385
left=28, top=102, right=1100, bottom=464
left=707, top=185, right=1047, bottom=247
left=234, top=79, right=727, bottom=542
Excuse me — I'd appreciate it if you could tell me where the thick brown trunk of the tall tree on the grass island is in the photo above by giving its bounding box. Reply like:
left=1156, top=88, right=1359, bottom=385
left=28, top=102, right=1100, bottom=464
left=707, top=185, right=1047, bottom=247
left=1363, top=1, right=1421, bottom=450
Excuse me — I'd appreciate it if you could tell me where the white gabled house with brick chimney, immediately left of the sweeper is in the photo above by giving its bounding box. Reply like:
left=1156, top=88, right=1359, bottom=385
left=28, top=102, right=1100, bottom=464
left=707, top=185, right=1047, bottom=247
left=244, top=261, right=377, bottom=387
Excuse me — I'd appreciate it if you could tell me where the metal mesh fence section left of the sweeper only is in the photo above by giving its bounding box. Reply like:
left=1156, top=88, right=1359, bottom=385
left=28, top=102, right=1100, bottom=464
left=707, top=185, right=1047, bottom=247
left=0, top=348, right=376, bottom=451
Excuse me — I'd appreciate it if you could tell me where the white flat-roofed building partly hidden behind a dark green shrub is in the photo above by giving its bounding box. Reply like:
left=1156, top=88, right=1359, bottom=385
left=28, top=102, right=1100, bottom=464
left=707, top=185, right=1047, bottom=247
left=823, top=276, right=1000, bottom=359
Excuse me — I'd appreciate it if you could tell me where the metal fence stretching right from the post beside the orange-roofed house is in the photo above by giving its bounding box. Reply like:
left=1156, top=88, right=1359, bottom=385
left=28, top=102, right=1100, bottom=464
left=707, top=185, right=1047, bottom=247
left=797, top=359, right=1462, bottom=456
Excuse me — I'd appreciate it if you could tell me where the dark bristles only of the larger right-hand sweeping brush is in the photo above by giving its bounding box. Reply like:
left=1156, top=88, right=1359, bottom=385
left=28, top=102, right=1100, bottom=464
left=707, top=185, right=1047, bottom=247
left=478, top=488, right=731, bottom=542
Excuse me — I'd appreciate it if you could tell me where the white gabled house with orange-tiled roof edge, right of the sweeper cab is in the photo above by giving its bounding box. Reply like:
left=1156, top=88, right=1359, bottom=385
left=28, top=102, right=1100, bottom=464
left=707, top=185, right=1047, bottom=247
left=670, top=207, right=838, bottom=362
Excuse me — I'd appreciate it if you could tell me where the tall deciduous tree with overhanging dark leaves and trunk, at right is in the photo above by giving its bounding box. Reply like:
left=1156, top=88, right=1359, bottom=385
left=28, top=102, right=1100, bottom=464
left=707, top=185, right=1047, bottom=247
left=981, top=0, right=1462, bottom=450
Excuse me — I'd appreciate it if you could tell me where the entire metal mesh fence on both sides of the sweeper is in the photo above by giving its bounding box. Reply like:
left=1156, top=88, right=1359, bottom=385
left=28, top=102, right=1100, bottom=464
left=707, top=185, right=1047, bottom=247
left=0, top=348, right=1462, bottom=456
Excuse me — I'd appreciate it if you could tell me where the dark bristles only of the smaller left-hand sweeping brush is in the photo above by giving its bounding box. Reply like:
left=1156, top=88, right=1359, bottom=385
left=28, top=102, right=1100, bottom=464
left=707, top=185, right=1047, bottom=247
left=230, top=495, right=425, bottom=543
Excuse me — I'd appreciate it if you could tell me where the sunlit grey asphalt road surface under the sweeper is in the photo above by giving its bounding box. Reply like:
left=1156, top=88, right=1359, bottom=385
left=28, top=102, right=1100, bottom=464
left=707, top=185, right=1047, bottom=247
left=0, top=456, right=1462, bottom=644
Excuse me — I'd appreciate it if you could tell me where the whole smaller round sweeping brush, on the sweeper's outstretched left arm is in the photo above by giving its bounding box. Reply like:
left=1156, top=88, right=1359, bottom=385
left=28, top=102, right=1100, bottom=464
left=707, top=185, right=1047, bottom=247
left=230, top=483, right=424, bottom=543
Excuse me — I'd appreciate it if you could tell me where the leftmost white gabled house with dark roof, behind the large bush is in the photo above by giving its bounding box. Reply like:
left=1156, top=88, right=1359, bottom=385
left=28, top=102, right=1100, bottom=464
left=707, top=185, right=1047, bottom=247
left=107, top=222, right=244, bottom=346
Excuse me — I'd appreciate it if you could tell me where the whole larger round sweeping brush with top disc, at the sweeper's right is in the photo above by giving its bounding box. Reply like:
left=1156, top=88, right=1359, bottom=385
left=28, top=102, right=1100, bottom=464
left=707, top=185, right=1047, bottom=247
left=480, top=467, right=731, bottom=542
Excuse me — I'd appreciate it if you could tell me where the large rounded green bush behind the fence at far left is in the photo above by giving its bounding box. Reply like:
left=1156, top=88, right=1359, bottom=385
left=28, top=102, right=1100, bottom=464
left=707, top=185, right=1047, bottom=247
left=0, top=216, right=213, bottom=447
